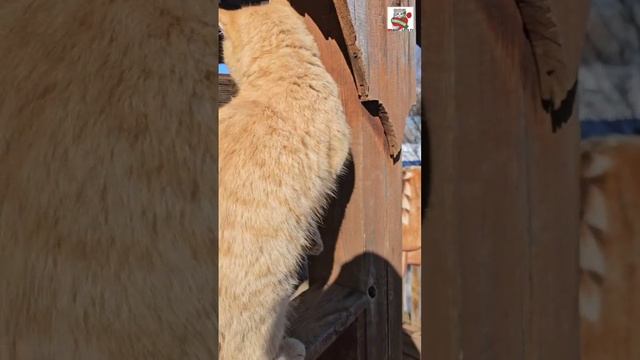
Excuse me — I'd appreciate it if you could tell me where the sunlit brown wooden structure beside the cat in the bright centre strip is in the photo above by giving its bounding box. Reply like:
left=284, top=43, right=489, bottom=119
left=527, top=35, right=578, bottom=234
left=219, top=0, right=415, bottom=360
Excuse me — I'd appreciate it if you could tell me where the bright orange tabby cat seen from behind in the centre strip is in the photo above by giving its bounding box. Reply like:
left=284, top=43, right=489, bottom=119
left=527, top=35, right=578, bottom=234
left=219, top=0, right=349, bottom=360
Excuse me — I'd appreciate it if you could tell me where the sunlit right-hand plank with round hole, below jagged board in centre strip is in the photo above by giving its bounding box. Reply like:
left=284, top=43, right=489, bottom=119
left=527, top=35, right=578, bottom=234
left=363, top=97, right=402, bottom=359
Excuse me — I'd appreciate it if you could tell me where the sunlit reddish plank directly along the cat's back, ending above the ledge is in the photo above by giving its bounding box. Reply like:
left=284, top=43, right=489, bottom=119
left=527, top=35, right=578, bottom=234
left=292, top=0, right=370, bottom=292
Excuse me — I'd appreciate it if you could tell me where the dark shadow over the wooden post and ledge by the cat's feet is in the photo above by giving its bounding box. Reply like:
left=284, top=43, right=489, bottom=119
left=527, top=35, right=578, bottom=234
left=290, top=251, right=420, bottom=360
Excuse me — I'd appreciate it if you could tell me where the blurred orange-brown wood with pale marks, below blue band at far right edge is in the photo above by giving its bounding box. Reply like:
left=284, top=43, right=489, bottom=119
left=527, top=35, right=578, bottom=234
left=580, top=136, right=640, bottom=360
